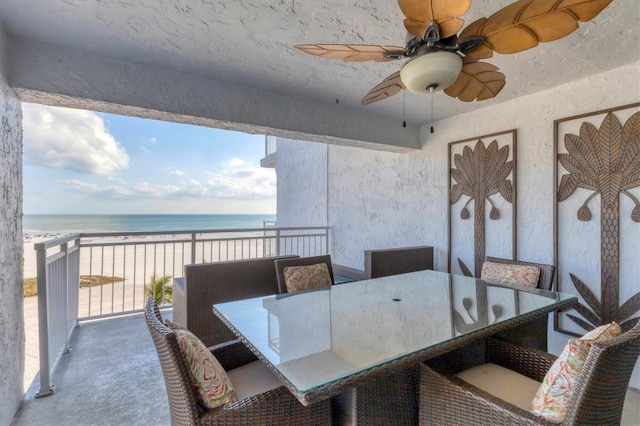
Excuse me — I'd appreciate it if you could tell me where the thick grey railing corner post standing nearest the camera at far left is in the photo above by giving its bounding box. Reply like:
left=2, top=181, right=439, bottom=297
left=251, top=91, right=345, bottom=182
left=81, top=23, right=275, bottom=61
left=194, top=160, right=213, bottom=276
left=34, top=243, right=54, bottom=397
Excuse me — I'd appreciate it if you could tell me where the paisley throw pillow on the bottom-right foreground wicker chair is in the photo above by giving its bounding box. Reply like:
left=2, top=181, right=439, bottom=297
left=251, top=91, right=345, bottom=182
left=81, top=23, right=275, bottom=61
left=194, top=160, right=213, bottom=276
left=531, top=322, right=622, bottom=423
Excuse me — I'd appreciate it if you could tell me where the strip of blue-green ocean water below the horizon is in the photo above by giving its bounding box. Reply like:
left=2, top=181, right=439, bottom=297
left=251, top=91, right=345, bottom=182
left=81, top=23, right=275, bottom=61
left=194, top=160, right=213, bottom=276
left=22, top=214, right=276, bottom=237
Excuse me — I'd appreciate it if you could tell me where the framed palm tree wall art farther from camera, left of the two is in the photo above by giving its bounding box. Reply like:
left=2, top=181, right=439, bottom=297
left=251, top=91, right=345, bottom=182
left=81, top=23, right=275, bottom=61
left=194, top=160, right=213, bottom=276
left=448, top=130, right=516, bottom=277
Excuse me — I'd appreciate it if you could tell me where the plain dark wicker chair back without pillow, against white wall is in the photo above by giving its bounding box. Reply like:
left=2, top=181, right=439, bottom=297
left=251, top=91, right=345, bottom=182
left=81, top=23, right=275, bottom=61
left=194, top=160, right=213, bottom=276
left=364, top=246, right=433, bottom=279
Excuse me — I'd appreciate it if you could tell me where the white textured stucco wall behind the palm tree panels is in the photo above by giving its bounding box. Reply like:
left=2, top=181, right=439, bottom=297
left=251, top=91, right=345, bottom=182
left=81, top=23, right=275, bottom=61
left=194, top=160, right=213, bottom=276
left=278, top=62, right=640, bottom=387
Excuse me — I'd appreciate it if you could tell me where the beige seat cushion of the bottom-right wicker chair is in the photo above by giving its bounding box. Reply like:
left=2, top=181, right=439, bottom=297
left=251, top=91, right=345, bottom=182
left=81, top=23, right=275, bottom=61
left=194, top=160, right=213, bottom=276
left=457, top=364, right=540, bottom=411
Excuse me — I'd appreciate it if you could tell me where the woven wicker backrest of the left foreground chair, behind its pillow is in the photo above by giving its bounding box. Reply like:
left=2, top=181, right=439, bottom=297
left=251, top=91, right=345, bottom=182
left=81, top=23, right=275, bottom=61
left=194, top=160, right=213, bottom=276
left=144, top=299, right=199, bottom=425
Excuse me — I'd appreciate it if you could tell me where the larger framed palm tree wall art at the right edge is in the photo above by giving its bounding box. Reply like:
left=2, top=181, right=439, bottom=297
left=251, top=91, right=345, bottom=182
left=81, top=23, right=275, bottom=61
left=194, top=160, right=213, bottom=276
left=555, top=104, right=640, bottom=334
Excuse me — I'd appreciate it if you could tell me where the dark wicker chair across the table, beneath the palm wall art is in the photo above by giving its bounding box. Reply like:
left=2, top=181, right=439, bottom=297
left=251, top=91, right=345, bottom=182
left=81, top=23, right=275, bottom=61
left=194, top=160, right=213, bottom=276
left=485, top=256, right=556, bottom=352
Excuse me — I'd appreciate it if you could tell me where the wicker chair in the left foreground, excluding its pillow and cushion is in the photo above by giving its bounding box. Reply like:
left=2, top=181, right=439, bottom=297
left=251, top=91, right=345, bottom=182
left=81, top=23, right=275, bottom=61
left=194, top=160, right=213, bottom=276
left=145, top=299, right=331, bottom=426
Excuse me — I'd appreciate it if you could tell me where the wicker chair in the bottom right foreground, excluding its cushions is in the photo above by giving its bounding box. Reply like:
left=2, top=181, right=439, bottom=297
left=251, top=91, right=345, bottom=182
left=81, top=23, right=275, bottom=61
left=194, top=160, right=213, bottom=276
left=420, top=323, right=640, bottom=425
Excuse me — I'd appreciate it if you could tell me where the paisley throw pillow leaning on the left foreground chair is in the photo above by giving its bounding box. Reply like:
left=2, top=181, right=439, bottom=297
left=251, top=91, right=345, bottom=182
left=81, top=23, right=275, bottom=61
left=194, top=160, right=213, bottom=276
left=166, top=321, right=237, bottom=410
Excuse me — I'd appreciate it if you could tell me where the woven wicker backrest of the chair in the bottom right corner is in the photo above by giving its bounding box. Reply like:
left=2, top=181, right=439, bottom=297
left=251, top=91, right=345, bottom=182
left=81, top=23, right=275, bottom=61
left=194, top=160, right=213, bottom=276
left=565, top=322, right=640, bottom=425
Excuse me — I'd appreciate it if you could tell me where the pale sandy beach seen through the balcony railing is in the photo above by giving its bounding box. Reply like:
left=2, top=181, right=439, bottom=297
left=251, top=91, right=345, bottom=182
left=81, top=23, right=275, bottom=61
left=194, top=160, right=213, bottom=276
left=24, top=236, right=264, bottom=390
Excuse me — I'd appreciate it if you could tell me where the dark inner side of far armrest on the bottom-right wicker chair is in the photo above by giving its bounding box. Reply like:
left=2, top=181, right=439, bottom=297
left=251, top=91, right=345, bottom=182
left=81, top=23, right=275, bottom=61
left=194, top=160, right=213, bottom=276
left=486, top=337, right=557, bottom=382
